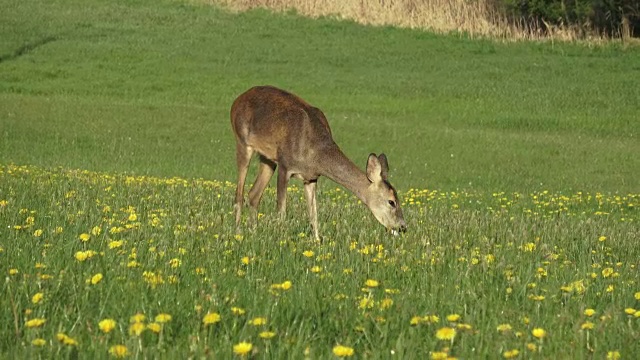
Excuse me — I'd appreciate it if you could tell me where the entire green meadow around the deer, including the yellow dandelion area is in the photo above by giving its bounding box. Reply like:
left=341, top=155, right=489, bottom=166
left=0, top=0, right=640, bottom=359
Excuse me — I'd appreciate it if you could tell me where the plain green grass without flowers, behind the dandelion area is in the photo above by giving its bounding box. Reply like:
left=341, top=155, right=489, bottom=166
left=0, top=0, right=640, bottom=192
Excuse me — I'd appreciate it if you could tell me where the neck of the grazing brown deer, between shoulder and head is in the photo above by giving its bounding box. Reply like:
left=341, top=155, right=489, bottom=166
left=318, top=145, right=370, bottom=204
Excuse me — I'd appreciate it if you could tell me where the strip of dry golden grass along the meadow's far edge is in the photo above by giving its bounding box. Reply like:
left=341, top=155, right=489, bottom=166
left=197, top=0, right=600, bottom=41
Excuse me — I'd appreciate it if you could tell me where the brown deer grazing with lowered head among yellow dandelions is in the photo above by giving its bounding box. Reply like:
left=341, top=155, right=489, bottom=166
left=231, top=86, right=407, bottom=239
